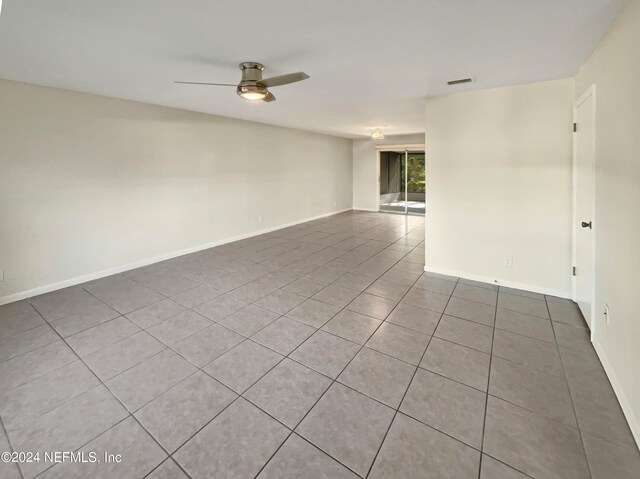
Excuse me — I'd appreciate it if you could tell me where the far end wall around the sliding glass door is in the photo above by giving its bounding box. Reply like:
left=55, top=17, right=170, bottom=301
left=353, top=133, right=424, bottom=211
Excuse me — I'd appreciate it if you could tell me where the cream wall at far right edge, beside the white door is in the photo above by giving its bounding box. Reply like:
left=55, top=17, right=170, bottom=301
left=575, top=0, right=640, bottom=443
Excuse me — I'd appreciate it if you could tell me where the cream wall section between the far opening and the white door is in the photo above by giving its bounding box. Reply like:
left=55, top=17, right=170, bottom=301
left=426, top=79, right=573, bottom=297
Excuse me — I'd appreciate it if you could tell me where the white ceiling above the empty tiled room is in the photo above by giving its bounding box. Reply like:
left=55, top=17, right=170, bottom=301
left=0, top=0, right=627, bottom=137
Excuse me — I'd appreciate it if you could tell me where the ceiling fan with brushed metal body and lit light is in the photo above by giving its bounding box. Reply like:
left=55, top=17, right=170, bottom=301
left=174, top=62, right=309, bottom=101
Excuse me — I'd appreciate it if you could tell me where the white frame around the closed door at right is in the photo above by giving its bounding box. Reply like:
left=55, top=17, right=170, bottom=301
left=571, top=84, right=598, bottom=341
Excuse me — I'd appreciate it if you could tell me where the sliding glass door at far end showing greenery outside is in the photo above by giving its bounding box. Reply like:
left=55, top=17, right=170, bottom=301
left=378, top=147, right=426, bottom=215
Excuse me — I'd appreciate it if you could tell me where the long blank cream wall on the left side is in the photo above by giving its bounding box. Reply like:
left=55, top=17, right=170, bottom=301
left=0, top=80, right=352, bottom=302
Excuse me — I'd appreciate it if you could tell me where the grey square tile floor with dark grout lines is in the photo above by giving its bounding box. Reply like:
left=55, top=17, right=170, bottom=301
left=0, top=212, right=640, bottom=479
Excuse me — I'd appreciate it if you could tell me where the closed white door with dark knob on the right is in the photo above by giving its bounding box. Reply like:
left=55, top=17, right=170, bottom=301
left=573, top=87, right=597, bottom=332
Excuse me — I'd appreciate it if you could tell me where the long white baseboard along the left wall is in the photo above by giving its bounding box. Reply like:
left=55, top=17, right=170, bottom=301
left=0, top=208, right=351, bottom=306
